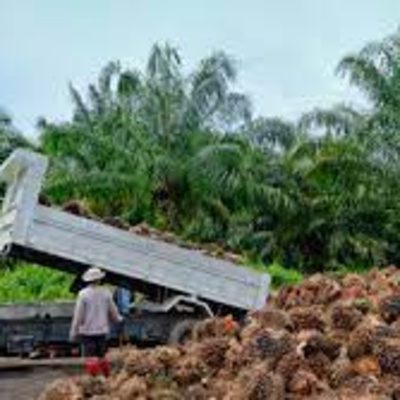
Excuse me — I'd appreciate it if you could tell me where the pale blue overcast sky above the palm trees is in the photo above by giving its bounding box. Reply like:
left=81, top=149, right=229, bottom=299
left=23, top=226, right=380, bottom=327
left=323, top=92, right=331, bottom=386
left=0, top=0, right=400, bottom=135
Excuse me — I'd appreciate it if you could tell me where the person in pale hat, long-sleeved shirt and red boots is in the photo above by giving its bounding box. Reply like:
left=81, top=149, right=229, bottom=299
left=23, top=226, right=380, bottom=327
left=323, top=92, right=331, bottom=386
left=70, top=267, right=122, bottom=376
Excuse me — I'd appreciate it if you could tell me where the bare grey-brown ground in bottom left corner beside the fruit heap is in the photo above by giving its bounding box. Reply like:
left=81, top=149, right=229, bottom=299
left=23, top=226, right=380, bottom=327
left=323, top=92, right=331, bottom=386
left=0, top=368, right=76, bottom=400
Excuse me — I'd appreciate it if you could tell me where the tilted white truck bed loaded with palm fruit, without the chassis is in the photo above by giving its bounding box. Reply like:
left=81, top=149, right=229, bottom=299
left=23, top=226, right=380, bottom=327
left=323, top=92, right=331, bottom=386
left=0, top=150, right=270, bottom=310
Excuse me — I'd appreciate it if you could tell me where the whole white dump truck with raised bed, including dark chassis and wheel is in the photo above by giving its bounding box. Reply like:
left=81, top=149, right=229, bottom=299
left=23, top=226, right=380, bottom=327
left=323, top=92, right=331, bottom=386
left=0, top=149, right=270, bottom=351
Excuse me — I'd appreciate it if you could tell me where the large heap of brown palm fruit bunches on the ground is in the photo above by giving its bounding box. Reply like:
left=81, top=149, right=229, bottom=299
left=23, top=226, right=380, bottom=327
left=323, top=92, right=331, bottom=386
left=41, top=267, right=400, bottom=400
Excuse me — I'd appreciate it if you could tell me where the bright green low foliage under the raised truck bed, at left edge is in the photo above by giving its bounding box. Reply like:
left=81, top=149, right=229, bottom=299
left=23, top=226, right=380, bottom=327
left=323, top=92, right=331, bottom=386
left=0, top=264, right=74, bottom=303
